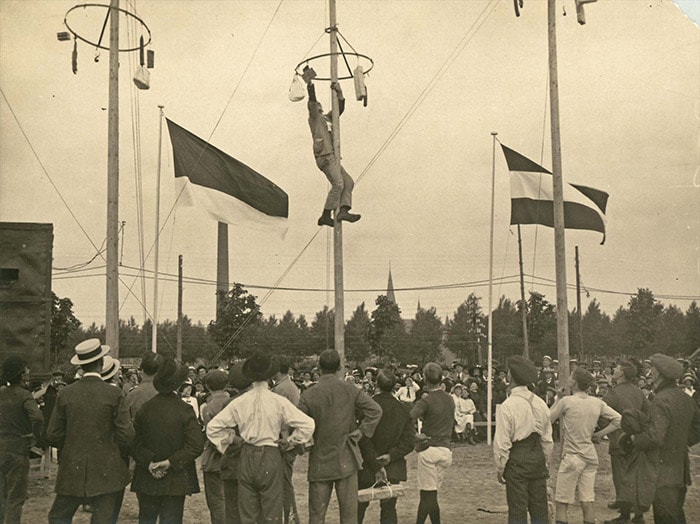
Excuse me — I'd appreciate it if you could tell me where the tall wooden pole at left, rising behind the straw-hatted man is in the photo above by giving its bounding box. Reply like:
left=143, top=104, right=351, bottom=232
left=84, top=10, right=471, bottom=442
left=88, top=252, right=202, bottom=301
left=105, top=0, right=119, bottom=358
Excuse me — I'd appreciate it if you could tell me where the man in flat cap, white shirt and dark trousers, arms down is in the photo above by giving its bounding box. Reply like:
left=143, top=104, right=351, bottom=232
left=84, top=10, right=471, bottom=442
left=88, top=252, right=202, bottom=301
left=493, top=356, right=553, bottom=524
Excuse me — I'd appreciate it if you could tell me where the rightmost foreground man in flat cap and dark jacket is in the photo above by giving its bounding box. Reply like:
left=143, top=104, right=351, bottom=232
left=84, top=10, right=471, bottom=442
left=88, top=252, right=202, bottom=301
left=632, top=353, right=700, bottom=524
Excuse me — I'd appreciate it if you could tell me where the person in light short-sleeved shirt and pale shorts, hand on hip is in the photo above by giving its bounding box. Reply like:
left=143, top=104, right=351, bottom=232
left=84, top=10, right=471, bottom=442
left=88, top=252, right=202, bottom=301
left=550, top=367, right=621, bottom=524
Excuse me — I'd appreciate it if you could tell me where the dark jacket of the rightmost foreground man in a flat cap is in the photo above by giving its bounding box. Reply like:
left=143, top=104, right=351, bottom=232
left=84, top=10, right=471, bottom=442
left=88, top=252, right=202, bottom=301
left=633, top=381, right=700, bottom=488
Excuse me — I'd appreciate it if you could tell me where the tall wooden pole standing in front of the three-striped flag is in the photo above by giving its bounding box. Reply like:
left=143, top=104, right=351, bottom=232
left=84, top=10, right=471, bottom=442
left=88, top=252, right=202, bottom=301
left=547, top=0, right=570, bottom=386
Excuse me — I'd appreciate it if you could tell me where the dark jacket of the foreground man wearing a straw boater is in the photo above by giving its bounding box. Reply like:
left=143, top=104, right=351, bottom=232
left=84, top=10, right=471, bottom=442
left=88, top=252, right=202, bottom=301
left=47, top=376, right=134, bottom=497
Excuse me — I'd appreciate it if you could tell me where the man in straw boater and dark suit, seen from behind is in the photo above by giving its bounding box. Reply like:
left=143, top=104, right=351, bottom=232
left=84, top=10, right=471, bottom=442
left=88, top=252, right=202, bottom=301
left=47, top=338, right=134, bottom=524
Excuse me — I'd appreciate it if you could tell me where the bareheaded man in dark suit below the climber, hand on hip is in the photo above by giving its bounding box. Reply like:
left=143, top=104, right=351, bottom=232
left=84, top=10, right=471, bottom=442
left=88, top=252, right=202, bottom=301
left=299, top=349, right=382, bottom=524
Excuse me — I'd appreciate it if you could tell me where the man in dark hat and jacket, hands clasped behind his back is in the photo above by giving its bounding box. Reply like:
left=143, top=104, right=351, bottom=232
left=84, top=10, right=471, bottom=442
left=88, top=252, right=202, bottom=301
left=131, top=358, right=204, bottom=524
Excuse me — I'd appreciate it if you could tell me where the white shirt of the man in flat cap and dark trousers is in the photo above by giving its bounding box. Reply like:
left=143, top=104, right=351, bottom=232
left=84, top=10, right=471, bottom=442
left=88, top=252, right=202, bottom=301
left=493, top=386, right=554, bottom=472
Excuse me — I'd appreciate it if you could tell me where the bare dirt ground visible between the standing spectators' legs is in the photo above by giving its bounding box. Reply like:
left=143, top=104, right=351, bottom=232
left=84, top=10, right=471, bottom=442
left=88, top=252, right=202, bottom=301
left=22, top=443, right=700, bottom=524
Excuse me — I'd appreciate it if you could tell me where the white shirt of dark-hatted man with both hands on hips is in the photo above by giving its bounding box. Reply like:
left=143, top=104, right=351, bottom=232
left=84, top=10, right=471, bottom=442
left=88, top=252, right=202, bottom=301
left=207, top=382, right=316, bottom=453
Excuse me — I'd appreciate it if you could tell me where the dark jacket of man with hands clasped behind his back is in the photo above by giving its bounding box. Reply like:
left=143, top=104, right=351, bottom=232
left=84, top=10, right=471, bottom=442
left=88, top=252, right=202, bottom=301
left=131, top=393, right=204, bottom=496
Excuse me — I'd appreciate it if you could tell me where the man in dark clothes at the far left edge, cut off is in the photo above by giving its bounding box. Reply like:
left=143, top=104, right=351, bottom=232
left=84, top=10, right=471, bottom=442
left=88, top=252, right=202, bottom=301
left=0, top=355, right=44, bottom=522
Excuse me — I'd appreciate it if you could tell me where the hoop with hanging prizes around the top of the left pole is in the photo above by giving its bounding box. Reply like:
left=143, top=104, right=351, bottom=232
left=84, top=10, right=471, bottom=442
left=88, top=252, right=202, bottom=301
left=56, top=3, right=155, bottom=89
